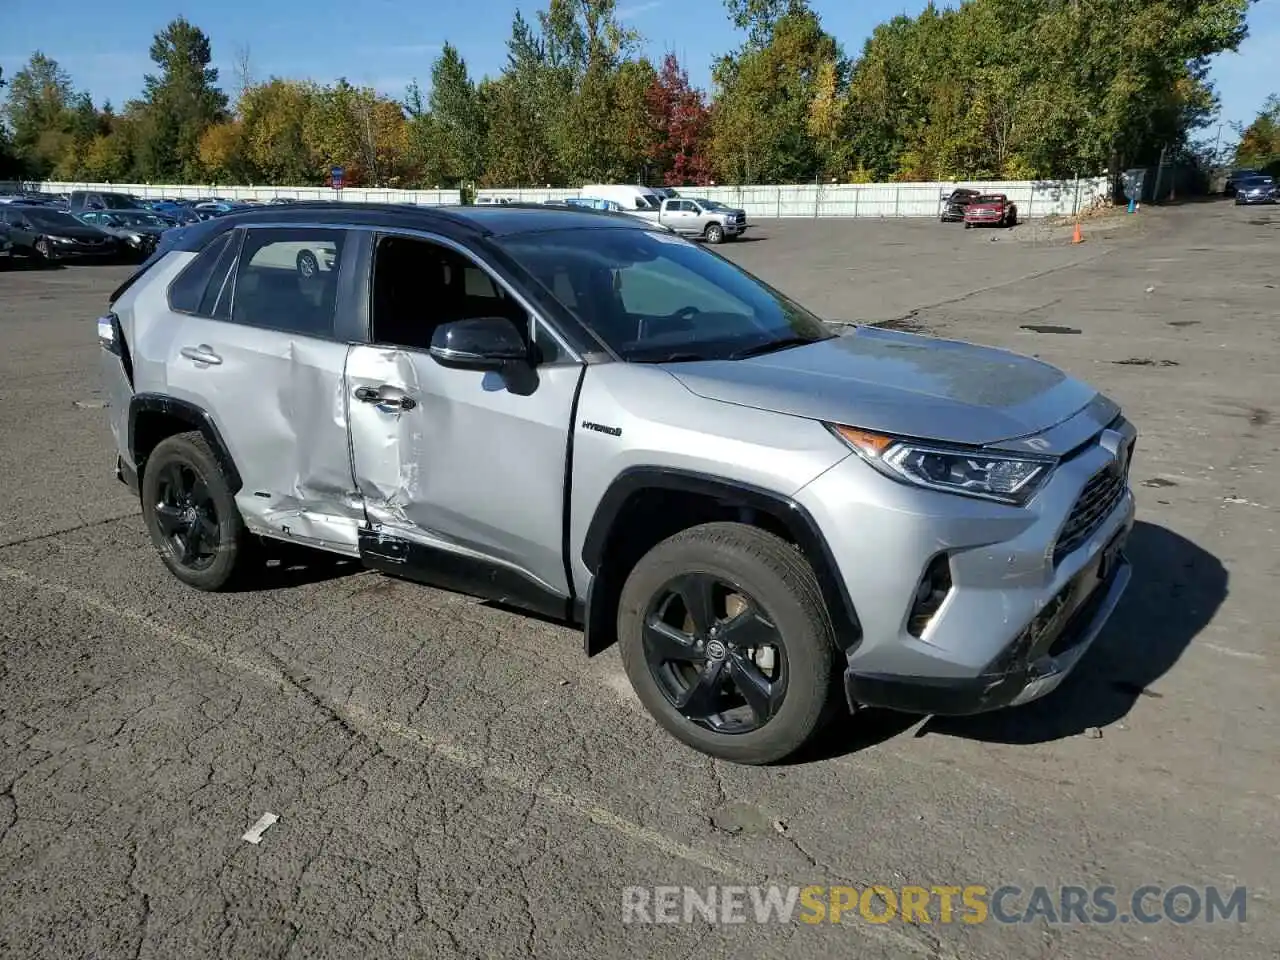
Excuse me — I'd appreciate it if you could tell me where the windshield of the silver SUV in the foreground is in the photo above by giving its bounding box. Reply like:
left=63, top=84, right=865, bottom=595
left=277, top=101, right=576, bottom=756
left=494, top=229, right=835, bottom=362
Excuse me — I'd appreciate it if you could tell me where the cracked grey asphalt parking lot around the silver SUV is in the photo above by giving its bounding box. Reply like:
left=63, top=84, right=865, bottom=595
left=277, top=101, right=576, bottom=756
left=0, top=204, right=1280, bottom=960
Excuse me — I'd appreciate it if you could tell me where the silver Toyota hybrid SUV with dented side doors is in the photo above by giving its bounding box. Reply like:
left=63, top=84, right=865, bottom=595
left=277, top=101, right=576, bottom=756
left=97, top=204, right=1135, bottom=763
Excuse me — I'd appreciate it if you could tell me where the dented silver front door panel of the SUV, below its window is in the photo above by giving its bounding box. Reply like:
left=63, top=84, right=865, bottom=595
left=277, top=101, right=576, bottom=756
left=346, top=346, right=581, bottom=595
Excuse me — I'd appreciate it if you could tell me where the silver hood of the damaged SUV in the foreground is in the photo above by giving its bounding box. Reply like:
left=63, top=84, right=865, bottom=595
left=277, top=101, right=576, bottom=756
left=663, top=326, right=1097, bottom=445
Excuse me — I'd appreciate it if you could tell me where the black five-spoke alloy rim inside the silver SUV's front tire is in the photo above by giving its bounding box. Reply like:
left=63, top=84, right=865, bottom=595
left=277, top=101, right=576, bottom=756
left=644, top=573, right=787, bottom=733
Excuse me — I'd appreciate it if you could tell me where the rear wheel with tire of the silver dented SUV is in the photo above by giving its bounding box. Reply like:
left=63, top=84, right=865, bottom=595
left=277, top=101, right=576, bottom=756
left=141, top=430, right=250, bottom=590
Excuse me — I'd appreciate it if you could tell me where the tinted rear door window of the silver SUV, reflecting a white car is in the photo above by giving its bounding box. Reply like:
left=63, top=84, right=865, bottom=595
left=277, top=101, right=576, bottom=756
left=230, top=227, right=346, bottom=337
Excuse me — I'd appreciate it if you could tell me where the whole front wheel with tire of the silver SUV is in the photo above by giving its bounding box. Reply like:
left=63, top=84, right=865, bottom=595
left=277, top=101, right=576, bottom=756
left=618, top=522, right=838, bottom=764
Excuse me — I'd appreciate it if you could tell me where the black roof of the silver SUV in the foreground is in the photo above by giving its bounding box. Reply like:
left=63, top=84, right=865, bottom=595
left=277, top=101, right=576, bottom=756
left=166, top=201, right=652, bottom=251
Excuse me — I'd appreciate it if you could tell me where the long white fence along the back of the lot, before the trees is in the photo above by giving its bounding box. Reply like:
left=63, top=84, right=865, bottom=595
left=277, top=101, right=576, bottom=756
left=0, top=177, right=1111, bottom=220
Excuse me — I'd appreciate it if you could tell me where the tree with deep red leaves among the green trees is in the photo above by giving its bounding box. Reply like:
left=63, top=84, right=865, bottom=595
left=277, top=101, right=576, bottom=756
left=645, top=54, right=710, bottom=187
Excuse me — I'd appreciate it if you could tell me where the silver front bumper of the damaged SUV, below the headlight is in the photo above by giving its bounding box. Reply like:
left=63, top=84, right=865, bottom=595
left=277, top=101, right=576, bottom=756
left=796, top=422, right=1137, bottom=714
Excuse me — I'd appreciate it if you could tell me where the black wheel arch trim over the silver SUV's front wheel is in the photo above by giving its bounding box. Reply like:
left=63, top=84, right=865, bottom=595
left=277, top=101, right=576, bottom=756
left=582, top=467, right=861, bottom=655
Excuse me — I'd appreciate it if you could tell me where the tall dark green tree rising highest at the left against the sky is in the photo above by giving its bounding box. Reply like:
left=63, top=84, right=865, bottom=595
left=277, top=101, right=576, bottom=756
left=138, top=17, right=227, bottom=182
